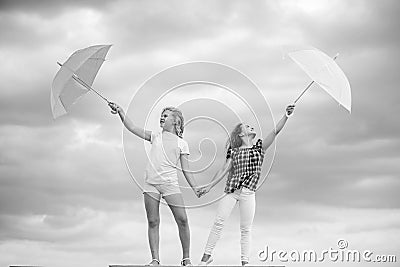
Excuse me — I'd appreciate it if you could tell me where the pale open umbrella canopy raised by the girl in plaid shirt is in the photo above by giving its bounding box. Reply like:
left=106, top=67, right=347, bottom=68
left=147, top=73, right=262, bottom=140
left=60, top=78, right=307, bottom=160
left=287, top=48, right=351, bottom=112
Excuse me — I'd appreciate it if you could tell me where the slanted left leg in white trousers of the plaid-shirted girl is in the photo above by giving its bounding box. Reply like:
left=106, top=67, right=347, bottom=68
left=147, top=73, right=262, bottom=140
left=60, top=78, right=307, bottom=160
left=201, top=193, right=237, bottom=262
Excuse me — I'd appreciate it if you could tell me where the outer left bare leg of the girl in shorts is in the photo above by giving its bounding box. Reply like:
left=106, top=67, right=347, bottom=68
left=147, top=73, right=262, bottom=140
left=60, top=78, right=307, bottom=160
left=143, top=192, right=160, bottom=264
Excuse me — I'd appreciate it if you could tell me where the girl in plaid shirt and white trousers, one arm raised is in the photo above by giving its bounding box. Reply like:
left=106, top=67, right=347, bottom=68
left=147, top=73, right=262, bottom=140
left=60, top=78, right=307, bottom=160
left=199, top=105, right=294, bottom=266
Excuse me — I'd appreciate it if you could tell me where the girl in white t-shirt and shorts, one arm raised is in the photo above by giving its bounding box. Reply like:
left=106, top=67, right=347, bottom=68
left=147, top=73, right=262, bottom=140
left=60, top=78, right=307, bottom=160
left=109, top=103, right=200, bottom=266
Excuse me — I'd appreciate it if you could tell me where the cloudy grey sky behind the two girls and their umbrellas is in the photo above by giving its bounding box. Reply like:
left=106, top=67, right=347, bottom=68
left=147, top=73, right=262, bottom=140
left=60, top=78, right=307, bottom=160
left=0, top=0, right=400, bottom=267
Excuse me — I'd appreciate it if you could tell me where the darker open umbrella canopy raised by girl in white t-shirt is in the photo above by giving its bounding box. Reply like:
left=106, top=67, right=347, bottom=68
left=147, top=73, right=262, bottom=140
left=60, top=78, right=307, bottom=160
left=51, top=45, right=111, bottom=118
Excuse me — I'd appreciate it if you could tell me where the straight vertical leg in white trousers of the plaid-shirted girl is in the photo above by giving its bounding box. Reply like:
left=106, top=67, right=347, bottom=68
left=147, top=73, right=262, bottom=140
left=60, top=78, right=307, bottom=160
left=239, top=188, right=256, bottom=265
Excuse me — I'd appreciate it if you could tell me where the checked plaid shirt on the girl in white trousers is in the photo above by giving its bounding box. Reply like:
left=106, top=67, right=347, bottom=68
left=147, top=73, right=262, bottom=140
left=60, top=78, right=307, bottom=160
left=224, top=139, right=265, bottom=193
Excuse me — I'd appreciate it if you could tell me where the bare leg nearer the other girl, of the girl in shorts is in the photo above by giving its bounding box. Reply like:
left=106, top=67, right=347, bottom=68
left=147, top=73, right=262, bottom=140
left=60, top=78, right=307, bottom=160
left=164, top=193, right=190, bottom=265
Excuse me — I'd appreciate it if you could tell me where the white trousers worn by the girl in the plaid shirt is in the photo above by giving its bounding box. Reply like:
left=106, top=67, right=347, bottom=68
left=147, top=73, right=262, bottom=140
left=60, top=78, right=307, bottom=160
left=204, top=188, right=256, bottom=262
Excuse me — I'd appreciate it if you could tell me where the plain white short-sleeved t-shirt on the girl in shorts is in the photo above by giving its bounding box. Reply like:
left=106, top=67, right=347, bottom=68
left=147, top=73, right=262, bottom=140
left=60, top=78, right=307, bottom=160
left=145, top=131, right=190, bottom=184
